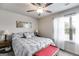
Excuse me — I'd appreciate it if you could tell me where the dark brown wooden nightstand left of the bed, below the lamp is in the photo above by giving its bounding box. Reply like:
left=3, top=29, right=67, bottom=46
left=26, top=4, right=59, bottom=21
left=0, top=40, right=12, bottom=53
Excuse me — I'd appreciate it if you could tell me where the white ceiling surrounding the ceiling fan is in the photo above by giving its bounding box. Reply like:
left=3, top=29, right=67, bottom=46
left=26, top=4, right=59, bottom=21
left=0, top=3, right=79, bottom=18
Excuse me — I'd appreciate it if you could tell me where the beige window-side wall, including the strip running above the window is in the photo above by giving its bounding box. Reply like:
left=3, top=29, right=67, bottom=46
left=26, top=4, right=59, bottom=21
left=39, top=6, right=79, bottom=38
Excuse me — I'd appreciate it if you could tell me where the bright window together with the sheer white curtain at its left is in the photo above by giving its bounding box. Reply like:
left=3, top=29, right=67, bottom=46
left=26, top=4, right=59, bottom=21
left=54, top=14, right=79, bottom=49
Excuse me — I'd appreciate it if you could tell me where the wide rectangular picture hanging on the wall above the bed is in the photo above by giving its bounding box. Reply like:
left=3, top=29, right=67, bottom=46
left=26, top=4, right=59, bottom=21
left=16, top=21, right=32, bottom=28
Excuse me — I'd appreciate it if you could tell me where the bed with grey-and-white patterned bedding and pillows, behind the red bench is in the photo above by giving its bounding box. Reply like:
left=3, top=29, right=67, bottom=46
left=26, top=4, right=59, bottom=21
left=12, top=33, right=55, bottom=56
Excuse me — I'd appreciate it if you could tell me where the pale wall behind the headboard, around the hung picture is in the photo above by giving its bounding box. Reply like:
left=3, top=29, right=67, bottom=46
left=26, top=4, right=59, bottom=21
left=0, top=9, right=38, bottom=32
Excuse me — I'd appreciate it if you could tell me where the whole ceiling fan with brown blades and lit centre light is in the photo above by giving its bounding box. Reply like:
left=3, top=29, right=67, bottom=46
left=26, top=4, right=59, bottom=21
left=26, top=3, right=53, bottom=16
